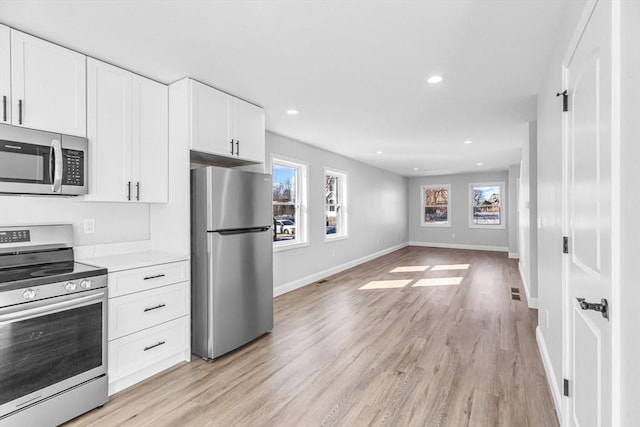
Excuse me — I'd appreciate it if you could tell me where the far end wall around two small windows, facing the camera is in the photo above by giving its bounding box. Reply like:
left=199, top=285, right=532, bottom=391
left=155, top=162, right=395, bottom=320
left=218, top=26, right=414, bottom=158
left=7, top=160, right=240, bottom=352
left=409, top=171, right=509, bottom=252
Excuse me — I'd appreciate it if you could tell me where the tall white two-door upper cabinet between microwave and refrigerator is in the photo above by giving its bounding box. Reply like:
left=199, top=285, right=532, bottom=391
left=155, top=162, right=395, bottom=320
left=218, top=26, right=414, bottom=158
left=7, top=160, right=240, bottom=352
left=86, top=58, right=169, bottom=202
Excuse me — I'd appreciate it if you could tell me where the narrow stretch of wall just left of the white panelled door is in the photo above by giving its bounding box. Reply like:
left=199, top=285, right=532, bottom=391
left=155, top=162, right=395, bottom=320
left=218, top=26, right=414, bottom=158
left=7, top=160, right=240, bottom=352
left=537, top=1, right=585, bottom=410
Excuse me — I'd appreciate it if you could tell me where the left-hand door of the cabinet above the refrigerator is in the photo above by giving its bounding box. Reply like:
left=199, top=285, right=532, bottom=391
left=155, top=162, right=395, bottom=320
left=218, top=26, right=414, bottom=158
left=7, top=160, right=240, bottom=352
left=190, top=80, right=235, bottom=157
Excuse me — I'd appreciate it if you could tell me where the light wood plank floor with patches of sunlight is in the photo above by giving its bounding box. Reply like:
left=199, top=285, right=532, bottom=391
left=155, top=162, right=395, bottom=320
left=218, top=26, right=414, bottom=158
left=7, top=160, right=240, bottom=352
left=63, top=247, right=558, bottom=427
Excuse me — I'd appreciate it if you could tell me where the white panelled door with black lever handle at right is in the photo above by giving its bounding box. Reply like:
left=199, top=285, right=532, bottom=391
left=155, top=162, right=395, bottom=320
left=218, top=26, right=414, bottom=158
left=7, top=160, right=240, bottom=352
left=565, top=1, right=615, bottom=427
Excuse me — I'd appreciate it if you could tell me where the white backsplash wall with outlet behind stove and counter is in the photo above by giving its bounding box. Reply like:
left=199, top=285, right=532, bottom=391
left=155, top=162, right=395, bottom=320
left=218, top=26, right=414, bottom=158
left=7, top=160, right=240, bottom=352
left=0, top=196, right=150, bottom=246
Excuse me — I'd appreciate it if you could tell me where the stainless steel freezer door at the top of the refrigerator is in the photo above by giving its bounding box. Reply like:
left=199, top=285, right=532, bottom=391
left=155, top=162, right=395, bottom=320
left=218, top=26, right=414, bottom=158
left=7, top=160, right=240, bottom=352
left=192, top=166, right=273, bottom=231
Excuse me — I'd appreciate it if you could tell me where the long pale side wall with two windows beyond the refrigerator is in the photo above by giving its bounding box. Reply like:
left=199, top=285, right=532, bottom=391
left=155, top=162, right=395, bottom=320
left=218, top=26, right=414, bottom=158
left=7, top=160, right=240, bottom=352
left=266, top=132, right=407, bottom=294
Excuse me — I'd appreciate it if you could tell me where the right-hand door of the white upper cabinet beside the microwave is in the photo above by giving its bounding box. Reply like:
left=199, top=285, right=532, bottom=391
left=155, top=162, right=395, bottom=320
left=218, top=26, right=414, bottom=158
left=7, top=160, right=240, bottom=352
left=132, top=75, right=169, bottom=203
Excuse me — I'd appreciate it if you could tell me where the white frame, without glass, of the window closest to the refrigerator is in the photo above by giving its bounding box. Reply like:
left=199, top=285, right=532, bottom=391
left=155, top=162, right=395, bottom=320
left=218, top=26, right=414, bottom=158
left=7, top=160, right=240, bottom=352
left=270, top=154, right=309, bottom=252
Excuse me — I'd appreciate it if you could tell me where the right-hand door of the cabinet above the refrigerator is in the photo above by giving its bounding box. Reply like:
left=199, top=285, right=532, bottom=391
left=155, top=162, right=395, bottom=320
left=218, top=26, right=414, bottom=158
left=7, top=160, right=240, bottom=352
left=233, top=98, right=265, bottom=163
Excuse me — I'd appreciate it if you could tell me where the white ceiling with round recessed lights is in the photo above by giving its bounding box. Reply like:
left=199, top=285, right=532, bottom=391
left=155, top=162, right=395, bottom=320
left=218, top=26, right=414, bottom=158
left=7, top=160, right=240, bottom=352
left=0, top=0, right=567, bottom=176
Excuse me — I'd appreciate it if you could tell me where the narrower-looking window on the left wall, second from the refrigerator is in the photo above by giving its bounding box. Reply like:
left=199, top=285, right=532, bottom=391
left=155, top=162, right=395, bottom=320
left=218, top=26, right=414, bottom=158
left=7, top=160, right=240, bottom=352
left=324, top=169, right=347, bottom=239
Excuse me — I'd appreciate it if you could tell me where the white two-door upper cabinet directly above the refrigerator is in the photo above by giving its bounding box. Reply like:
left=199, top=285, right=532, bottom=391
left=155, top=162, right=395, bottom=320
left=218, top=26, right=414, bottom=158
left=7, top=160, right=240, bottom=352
left=189, top=80, right=265, bottom=164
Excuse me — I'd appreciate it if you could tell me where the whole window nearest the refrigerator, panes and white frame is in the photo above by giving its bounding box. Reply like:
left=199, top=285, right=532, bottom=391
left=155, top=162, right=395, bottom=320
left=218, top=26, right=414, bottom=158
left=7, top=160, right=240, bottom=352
left=271, top=157, right=307, bottom=248
